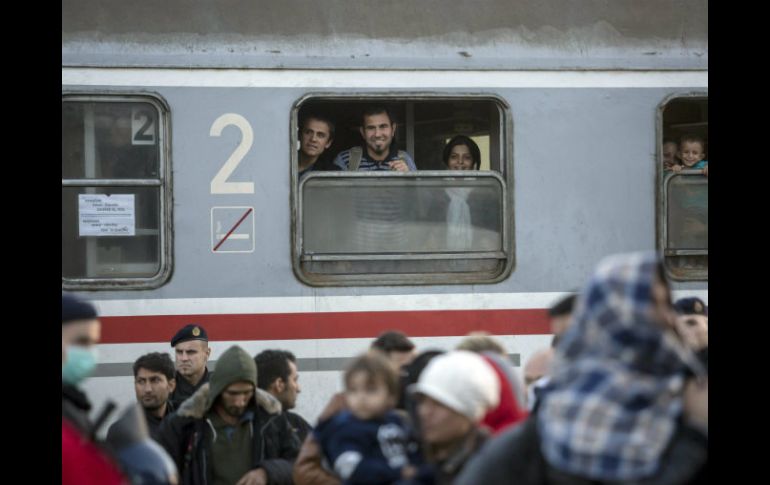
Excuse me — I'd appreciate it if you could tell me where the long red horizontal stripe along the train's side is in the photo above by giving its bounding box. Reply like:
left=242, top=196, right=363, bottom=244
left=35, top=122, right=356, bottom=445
left=101, top=309, right=551, bottom=344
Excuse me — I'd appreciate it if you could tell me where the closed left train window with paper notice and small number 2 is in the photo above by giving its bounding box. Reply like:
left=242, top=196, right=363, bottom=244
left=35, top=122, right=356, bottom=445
left=62, top=93, right=171, bottom=289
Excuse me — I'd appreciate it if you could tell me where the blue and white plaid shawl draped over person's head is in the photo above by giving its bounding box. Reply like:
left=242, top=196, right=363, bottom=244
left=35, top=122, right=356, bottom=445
left=537, top=252, right=699, bottom=480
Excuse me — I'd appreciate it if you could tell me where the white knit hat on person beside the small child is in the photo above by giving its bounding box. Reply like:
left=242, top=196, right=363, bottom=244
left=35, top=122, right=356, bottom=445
left=412, top=350, right=500, bottom=422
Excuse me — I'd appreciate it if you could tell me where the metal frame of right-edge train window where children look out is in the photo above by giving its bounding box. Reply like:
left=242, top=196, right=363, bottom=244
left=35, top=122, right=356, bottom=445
left=655, top=91, right=708, bottom=282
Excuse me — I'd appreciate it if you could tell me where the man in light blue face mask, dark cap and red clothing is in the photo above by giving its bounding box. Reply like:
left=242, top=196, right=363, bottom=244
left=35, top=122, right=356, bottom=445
left=61, top=294, right=128, bottom=485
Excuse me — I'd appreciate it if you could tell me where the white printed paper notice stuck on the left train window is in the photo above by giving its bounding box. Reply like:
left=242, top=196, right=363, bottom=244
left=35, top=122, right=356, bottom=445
left=78, top=194, right=136, bottom=237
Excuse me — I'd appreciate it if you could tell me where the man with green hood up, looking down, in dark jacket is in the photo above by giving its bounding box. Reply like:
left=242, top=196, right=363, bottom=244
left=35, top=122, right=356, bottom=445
left=160, top=346, right=299, bottom=485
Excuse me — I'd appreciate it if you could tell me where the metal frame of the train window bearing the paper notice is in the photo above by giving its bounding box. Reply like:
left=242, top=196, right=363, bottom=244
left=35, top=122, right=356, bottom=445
left=62, top=90, right=173, bottom=291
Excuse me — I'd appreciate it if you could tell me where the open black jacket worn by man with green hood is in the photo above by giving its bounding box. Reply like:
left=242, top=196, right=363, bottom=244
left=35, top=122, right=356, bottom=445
left=159, top=384, right=299, bottom=485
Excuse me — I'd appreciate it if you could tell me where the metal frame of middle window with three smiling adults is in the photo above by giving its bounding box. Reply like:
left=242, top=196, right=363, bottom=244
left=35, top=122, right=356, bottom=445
left=289, top=91, right=516, bottom=287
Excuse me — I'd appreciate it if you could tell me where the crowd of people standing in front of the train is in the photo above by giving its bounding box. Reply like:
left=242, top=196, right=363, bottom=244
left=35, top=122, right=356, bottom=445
left=62, top=253, right=708, bottom=485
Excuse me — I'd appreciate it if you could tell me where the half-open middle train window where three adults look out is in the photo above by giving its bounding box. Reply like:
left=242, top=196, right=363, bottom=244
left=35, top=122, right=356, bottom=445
left=291, top=94, right=513, bottom=286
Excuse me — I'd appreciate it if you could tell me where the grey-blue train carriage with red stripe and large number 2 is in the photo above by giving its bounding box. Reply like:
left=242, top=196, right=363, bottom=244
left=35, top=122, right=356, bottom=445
left=62, top=0, right=708, bottom=421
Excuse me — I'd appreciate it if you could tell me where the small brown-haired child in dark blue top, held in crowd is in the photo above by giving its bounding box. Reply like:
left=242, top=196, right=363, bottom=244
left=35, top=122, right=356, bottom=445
left=313, top=351, right=430, bottom=484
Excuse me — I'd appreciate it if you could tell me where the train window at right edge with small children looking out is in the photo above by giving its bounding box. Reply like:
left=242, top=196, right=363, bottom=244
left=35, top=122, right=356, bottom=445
left=657, top=93, right=708, bottom=280
